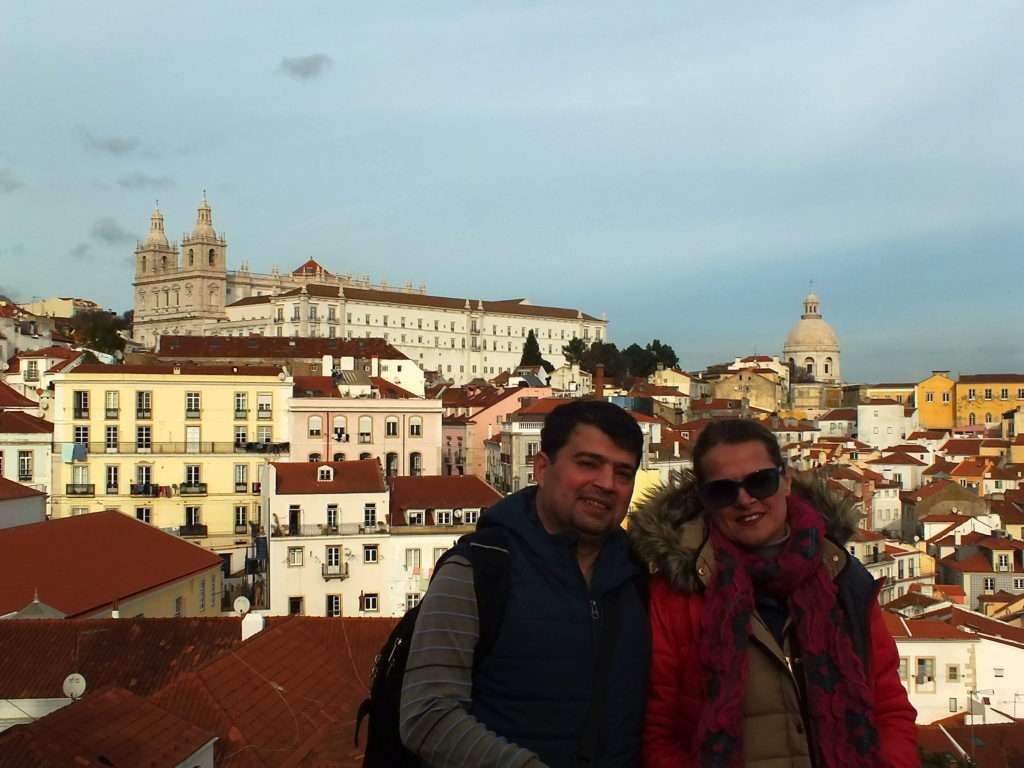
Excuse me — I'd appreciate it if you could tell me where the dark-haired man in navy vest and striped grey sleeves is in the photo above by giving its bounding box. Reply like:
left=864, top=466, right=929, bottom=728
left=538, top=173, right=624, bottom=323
left=399, top=400, right=650, bottom=768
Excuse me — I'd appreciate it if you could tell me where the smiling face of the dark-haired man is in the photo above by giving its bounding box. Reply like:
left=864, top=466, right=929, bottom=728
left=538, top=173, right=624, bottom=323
left=534, top=424, right=637, bottom=538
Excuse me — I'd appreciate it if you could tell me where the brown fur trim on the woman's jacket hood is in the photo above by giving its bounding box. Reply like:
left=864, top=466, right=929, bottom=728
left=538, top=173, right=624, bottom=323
left=629, top=470, right=859, bottom=592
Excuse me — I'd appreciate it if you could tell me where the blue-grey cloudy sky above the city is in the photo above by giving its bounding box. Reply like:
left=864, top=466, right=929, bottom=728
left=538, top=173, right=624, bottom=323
left=0, top=0, right=1024, bottom=381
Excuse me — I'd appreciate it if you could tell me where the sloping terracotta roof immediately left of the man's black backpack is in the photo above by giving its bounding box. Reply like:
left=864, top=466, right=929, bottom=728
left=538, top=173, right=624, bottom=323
left=151, top=616, right=397, bottom=768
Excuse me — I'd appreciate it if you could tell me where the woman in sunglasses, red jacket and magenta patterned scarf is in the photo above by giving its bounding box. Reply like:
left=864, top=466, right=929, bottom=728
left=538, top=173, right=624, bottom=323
left=630, top=420, right=919, bottom=768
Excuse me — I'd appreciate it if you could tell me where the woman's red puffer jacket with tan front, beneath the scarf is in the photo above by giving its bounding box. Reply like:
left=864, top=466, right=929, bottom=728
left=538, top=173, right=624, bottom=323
left=643, top=577, right=921, bottom=768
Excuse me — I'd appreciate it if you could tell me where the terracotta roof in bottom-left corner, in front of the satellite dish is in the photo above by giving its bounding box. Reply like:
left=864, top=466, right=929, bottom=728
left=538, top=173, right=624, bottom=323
left=0, top=688, right=214, bottom=768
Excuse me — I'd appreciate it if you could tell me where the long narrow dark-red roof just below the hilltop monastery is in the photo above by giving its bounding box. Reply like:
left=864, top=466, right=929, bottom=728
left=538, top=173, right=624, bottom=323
left=157, top=336, right=409, bottom=360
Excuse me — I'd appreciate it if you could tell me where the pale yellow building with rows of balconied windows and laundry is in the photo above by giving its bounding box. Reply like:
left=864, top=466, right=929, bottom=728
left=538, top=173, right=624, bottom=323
left=51, top=364, right=292, bottom=568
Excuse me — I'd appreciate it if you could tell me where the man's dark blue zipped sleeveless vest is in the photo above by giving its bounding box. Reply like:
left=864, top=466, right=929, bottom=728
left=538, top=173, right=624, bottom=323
left=471, top=488, right=650, bottom=768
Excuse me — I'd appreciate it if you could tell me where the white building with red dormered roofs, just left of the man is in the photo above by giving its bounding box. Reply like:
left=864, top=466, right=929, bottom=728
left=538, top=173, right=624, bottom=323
left=264, top=460, right=501, bottom=616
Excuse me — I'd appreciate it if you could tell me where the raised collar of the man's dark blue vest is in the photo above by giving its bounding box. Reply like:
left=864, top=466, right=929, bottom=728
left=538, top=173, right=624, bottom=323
left=477, top=485, right=641, bottom=594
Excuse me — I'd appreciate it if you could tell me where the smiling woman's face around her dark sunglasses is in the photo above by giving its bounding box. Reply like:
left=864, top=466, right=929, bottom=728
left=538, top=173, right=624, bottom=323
left=701, top=440, right=790, bottom=549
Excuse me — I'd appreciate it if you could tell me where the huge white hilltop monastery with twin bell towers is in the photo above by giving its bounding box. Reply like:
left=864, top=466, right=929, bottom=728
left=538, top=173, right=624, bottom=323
left=133, top=200, right=608, bottom=383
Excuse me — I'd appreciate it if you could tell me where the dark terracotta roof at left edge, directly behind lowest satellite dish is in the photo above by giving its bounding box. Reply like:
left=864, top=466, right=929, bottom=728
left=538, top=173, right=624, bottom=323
left=0, top=616, right=242, bottom=698
